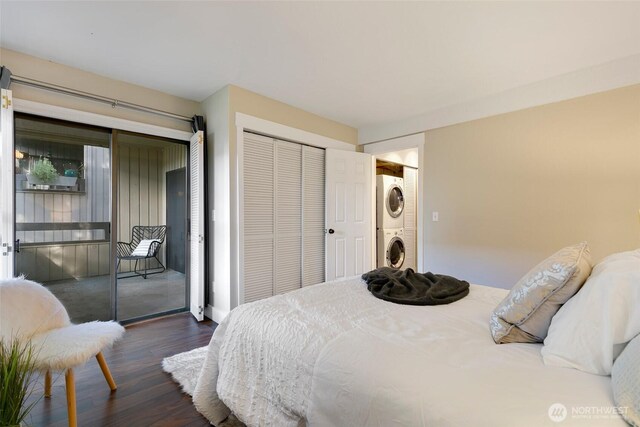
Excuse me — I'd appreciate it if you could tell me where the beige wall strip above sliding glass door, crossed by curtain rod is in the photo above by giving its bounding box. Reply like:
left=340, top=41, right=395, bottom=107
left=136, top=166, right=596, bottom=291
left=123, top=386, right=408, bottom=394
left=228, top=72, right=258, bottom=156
left=0, top=49, right=201, bottom=131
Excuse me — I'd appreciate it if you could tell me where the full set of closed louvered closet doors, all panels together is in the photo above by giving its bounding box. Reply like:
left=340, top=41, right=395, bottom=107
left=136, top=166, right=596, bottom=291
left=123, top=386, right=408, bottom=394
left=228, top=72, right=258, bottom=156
left=240, top=132, right=325, bottom=303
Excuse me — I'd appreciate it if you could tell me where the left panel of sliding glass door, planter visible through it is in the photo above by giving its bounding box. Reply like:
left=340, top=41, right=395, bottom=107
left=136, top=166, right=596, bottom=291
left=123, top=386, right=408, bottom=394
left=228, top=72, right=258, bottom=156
left=15, top=114, right=112, bottom=322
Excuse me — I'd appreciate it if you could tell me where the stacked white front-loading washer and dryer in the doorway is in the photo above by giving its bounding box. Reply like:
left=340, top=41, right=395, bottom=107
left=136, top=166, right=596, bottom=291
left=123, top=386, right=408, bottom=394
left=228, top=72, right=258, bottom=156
left=376, top=175, right=406, bottom=268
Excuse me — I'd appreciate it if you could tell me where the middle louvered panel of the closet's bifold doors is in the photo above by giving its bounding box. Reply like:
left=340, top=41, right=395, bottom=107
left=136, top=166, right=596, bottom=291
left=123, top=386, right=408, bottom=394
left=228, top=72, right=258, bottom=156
left=274, top=140, right=302, bottom=294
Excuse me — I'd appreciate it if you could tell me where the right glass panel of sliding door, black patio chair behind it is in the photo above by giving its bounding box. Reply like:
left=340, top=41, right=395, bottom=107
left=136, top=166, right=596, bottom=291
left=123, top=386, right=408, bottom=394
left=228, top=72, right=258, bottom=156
left=116, top=132, right=188, bottom=320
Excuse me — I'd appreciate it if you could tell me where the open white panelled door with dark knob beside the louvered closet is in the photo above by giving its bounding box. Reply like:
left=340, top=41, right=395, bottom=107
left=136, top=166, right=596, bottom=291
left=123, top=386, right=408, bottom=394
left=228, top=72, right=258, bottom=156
left=325, top=149, right=375, bottom=281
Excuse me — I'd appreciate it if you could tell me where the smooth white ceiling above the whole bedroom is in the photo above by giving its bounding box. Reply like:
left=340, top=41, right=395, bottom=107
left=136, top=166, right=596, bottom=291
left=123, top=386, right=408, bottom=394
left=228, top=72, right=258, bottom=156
left=0, top=1, right=640, bottom=131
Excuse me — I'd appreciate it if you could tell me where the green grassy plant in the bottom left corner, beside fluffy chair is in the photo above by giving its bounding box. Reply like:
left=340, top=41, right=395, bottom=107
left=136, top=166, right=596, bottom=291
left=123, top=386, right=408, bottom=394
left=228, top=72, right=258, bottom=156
left=0, top=339, right=36, bottom=427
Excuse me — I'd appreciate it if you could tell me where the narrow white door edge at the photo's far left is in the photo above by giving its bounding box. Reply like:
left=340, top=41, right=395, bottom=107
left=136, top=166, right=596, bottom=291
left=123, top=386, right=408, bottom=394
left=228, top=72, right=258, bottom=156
left=0, top=89, right=15, bottom=279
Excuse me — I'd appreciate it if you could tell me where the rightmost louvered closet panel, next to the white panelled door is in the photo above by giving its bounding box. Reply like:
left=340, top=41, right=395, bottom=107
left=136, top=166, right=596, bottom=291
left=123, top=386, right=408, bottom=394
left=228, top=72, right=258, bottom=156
left=302, top=146, right=325, bottom=286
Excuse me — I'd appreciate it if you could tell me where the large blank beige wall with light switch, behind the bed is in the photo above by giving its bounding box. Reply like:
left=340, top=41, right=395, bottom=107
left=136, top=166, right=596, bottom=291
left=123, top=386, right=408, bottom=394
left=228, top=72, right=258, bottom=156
left=423, top=85, right=640, bottom=288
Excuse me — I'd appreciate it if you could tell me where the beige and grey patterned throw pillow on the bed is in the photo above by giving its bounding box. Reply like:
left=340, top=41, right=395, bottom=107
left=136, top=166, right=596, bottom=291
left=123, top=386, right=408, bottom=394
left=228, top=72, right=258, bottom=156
left=489, top=242, right=591, bottom=344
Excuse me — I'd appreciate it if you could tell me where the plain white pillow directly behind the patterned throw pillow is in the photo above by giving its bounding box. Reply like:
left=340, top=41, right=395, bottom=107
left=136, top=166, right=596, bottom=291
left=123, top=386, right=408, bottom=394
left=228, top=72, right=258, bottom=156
left=542, top=249, right=640, bottom=375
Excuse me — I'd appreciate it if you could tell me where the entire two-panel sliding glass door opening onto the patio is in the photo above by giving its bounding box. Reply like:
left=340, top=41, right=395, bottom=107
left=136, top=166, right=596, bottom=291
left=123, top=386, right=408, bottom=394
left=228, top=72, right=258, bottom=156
left=14, top=114, right=188, bottom=322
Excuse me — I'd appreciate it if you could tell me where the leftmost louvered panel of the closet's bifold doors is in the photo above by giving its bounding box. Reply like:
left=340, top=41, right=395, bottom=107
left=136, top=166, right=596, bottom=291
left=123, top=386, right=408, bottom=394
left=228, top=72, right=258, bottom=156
left=241, top=133, right=275, bottom=302
